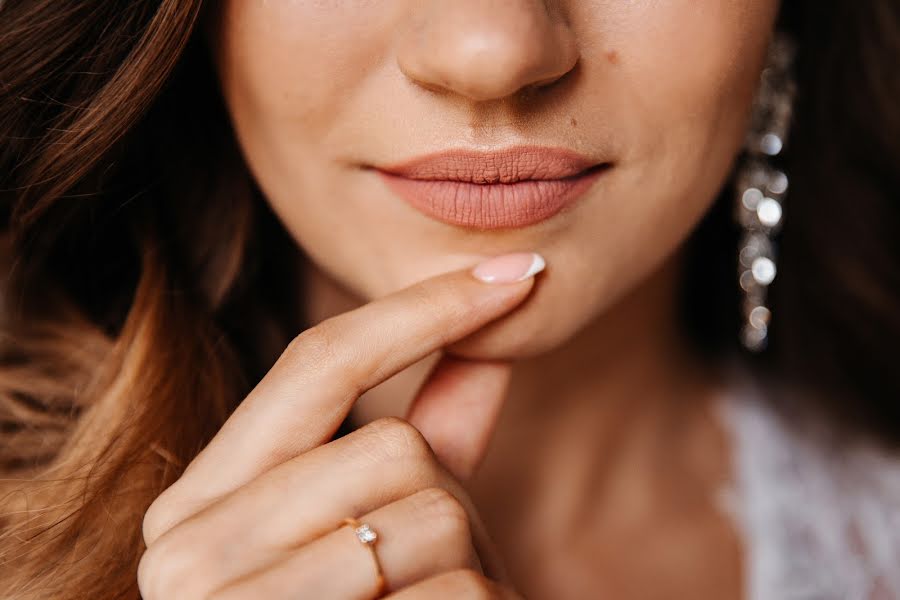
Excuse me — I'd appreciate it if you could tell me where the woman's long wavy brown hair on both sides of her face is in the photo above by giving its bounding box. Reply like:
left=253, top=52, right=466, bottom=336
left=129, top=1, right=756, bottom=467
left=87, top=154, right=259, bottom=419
left=0, top=0, right=900, bottom=598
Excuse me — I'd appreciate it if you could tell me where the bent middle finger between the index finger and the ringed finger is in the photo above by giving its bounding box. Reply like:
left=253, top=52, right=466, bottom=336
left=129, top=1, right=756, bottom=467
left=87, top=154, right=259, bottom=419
left=139, top=417, right=495, bottom=597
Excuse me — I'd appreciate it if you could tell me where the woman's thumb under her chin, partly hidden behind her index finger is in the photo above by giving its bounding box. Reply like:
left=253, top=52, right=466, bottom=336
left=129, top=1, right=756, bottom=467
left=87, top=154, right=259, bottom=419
left=406, top=353, right=511, bottom=480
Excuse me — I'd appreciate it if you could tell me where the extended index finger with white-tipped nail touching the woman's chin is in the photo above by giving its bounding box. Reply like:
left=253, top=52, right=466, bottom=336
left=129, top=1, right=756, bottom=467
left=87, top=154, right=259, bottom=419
left=144, top=253, right=544, bottom=545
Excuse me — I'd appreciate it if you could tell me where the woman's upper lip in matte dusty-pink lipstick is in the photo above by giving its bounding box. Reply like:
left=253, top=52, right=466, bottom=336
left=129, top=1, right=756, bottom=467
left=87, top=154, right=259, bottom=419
left=377, top=146, right=602, bottom=184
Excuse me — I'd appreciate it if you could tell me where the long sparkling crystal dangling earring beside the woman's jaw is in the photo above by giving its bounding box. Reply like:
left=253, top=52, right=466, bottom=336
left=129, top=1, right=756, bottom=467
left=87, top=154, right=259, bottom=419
left=735, top=32, right=796, bottom=352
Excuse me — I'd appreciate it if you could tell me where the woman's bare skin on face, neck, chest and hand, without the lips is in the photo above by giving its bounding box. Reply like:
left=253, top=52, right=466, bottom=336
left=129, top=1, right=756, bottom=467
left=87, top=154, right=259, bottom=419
left=139, top=0, right=778, bottom=599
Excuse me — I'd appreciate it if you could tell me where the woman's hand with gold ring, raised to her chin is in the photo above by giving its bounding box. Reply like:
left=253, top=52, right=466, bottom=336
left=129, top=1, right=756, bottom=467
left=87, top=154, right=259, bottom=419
left=138, top=254, right=543, bottom=600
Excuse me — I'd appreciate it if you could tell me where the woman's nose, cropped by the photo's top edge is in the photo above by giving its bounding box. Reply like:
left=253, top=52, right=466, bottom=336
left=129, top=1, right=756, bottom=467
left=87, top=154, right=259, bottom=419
left=398, top=0, right=579, bottom=101
